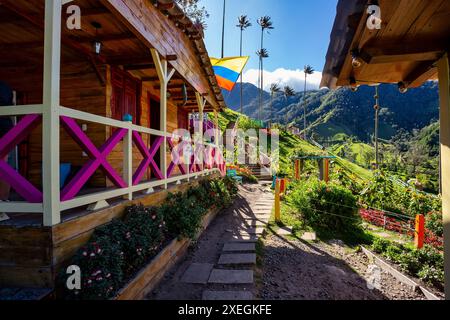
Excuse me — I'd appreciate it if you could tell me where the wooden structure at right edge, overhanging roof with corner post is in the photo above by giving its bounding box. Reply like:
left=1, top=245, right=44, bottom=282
left=321, top=0, right=450, bottom=299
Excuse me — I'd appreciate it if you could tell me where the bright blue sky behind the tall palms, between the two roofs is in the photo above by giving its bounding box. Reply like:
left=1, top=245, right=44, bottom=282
left=201, top=0, right=337, bottom=87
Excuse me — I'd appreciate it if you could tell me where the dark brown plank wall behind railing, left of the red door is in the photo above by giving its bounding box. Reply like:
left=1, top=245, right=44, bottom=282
left=0, top=57, right=106, bottom=187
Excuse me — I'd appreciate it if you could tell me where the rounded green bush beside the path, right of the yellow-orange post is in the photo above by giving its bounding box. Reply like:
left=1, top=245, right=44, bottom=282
left=287, top=178, right=361, bottom=234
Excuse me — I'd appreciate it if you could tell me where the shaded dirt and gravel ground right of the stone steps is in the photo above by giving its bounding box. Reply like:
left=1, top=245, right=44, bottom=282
left=258, top=235, right=425, bottom=300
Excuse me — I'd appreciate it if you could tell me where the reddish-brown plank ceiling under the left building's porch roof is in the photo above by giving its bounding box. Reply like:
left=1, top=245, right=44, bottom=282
left=0, top=0, right=224, bottom=111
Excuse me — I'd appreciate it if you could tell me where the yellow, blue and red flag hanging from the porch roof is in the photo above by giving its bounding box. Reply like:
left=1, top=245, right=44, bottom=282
left=211, top=57, right=250, bottom=91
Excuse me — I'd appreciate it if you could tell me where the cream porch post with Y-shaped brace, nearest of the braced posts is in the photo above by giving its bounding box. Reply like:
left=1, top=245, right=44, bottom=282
left=150, top=49, right=175, bottom=189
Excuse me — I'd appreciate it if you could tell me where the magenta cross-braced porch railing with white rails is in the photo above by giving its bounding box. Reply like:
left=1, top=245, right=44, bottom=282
left=0, top=107, right=226, bottom=214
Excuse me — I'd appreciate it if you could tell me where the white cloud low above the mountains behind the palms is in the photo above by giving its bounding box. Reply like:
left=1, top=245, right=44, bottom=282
left=243, top=68, right=322, bottom=91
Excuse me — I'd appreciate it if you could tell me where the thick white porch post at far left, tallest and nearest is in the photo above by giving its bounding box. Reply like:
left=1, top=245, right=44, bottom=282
left=42, top=0, right=62, bottom=226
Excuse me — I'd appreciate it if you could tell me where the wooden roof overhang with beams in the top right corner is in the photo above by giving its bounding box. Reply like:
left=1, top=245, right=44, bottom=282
left=321, top=0, right=450, bottom=89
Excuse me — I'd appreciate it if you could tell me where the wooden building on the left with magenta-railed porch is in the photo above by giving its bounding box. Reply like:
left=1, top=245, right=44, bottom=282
left=0, top=0, right=225, bottom=287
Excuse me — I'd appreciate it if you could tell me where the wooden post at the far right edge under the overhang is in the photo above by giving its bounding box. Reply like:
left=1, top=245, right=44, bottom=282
left=438, top=53, right=450, bottom=300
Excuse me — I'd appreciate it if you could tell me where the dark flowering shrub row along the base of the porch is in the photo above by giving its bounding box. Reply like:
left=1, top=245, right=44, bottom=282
left=60, top=179, right=237, bottom=300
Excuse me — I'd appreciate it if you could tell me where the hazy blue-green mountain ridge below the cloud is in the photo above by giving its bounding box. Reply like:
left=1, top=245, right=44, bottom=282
left=224, top=81, right=439, bottom=141
